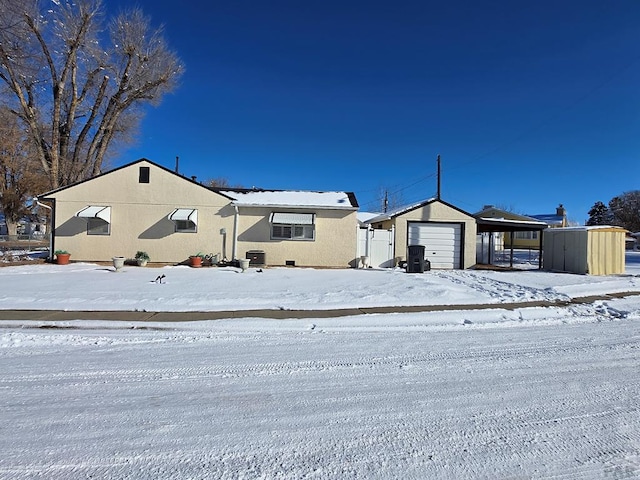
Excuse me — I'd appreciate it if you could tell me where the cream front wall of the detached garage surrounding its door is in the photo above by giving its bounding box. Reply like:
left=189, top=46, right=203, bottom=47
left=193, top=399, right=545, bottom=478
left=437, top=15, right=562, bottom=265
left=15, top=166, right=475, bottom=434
left=395, top=201, right=476, bottom=268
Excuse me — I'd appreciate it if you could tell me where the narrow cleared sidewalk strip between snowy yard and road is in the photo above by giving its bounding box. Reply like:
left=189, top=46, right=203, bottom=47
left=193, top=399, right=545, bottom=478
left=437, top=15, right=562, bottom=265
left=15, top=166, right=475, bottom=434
left=0, top=292, right=640, bottom=322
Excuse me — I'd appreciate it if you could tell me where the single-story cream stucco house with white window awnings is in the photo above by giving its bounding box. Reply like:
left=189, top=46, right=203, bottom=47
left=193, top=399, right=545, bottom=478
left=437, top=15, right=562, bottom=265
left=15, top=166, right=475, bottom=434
left=39, top=159, right=358, bottom=267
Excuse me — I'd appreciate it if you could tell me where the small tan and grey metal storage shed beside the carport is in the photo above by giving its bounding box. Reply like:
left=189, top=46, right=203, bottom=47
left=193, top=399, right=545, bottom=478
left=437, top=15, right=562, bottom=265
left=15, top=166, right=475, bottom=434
left=543, top=226, right=626, bottom=275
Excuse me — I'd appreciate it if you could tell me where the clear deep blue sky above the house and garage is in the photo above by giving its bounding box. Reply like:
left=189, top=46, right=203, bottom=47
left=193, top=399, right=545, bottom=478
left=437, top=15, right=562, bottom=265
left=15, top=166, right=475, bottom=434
left=107, top=0, right=640, bottom=223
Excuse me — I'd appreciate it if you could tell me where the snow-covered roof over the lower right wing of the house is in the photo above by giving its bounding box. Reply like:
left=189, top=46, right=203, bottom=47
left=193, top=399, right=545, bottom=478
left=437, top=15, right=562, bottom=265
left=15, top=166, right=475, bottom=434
left=217, top=189, right=358, bottom=210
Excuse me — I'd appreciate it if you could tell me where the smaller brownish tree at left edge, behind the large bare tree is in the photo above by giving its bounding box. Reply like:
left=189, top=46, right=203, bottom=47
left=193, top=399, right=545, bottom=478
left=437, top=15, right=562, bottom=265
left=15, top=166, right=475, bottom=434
left=0, top=108, right=47, bottom=235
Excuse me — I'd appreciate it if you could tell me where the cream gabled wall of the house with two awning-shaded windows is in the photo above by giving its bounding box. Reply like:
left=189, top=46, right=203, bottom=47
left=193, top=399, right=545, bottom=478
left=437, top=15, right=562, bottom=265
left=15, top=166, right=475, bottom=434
left=45, top=162, right=233, bottom=263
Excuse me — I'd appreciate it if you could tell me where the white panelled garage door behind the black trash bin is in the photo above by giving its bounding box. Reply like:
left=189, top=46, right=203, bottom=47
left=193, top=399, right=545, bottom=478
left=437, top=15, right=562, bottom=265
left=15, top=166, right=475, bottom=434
left=408, top=223, right=462, bottom=268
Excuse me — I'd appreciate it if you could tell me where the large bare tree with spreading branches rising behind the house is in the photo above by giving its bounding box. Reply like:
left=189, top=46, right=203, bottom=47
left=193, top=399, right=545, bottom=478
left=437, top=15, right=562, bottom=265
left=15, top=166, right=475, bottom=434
left=0, top=0, right=184, bottom=188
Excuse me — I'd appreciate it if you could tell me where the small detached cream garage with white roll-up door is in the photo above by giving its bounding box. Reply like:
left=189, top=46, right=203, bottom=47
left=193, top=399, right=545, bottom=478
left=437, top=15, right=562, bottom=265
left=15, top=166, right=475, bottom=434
left=369, top=198, right=476, bottom=269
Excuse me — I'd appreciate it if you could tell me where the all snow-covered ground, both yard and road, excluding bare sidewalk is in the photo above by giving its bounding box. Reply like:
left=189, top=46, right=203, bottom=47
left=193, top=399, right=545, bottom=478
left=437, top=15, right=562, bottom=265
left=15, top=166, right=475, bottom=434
left=0, top=253, right=640, bottom=479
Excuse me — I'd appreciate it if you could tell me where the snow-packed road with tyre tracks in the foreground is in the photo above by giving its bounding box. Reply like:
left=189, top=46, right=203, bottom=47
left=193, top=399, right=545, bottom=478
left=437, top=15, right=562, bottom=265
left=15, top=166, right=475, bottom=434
left=0, top=310, right=640, bottom=479
